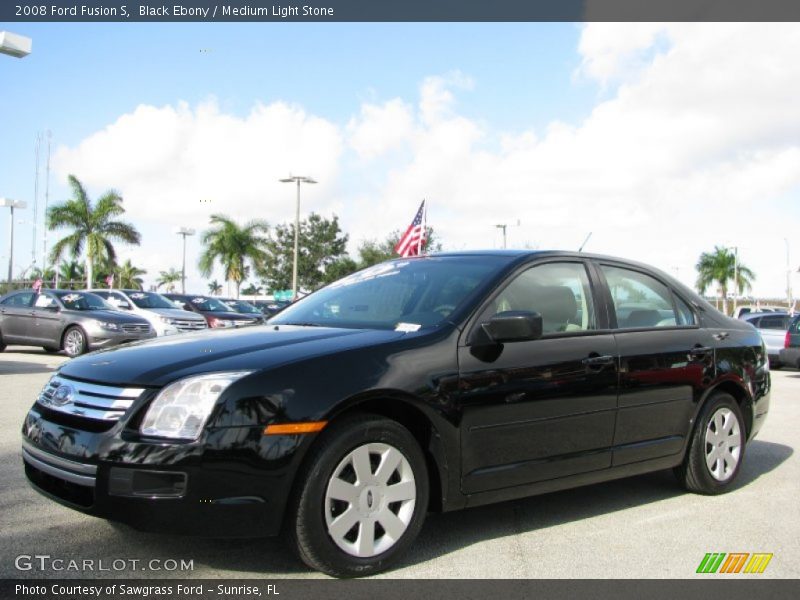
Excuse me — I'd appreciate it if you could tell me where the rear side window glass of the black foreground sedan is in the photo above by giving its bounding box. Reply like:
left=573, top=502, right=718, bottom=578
left=601, top=265, right=694, bottom=329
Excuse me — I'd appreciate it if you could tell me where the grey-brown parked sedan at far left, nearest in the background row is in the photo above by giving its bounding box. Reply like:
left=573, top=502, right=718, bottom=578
left=0, top=290, right=155, bottom=356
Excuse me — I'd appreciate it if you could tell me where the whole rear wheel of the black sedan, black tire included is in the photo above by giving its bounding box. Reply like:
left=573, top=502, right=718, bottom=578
left=675, top=392, right=747, bottom=495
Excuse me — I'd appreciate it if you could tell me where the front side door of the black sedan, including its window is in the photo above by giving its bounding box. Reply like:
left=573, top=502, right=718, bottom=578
left=458, top=260, right=618, bottom=494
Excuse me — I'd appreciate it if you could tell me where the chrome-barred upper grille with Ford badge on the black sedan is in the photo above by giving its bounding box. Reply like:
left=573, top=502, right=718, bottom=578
left=37, top=376, right=144, bottom=423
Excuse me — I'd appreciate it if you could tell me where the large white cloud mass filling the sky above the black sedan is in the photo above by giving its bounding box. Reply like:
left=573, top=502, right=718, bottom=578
left=50, top=24, right=800, bottom=296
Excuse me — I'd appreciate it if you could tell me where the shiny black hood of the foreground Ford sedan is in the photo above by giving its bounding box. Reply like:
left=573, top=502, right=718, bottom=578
left=59, top=325, right=406, bottom=387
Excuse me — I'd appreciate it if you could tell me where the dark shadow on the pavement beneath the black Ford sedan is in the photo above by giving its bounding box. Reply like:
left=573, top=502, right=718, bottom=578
left=9, top=440, right=793, bottom=577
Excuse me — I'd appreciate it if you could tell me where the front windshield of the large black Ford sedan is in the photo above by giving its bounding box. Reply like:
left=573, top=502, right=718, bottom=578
left=270, top=256, right=508, bottom=331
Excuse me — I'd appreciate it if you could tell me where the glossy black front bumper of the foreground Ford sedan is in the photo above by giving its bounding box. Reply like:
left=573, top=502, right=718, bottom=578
left=22, top=405, right=299, bottom=537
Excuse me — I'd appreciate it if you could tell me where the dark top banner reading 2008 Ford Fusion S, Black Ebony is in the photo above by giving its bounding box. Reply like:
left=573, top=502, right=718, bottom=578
left=0, top=0, right=800, bottom=22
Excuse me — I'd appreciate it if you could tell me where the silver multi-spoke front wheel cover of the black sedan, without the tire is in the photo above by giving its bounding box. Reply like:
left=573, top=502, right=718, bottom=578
left=325, top=443, right=417, bottom=558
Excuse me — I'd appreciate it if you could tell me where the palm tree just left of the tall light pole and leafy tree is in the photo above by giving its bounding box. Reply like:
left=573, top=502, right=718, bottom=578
left=199, top=214, right=269, bottom=298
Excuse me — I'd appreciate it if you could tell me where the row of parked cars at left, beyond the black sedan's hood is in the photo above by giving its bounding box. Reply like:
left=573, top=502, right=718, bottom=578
left=0, top=289, right=278, bottom=357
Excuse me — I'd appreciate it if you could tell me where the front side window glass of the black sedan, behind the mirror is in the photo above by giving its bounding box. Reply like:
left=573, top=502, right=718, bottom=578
left=481, top=263, right=597, bottom=335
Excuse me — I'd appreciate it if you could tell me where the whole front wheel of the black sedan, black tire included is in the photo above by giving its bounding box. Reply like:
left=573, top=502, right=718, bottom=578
left=286, top=415, right=429, bottom=577
